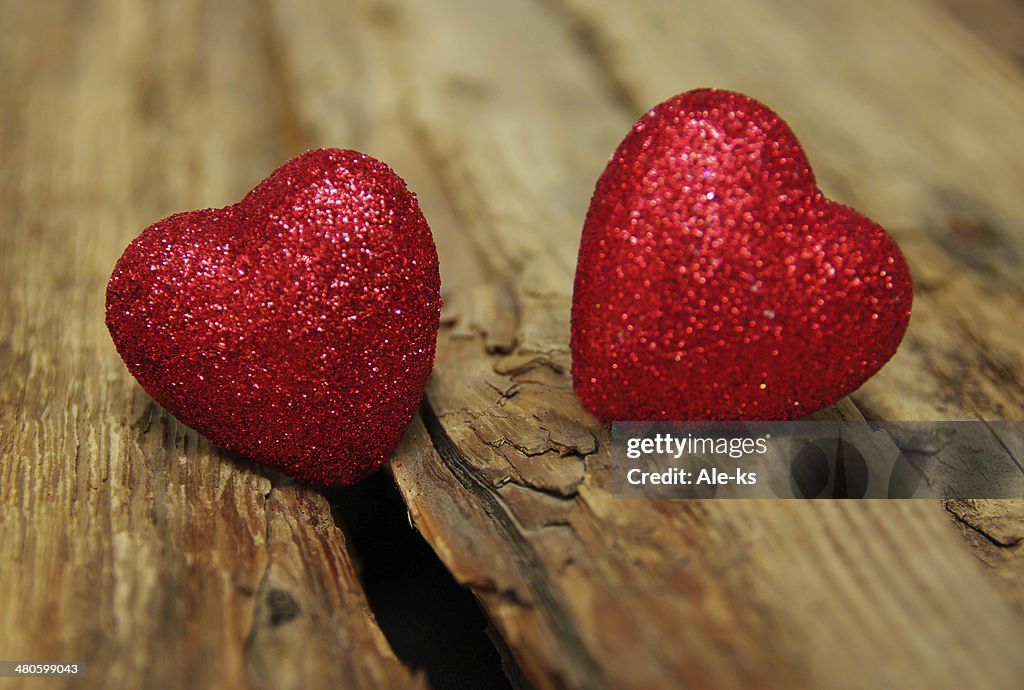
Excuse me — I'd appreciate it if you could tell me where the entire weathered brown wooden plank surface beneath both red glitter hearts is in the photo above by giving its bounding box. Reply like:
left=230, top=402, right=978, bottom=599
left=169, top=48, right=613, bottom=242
left=0, top=0, right=1024, bottom=689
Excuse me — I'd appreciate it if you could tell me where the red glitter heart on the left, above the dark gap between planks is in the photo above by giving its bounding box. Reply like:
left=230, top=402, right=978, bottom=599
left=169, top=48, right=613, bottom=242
left=106, top=148, right=440, bottom=484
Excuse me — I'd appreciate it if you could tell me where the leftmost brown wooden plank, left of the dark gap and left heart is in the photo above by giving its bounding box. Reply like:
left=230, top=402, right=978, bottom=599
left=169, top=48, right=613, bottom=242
left=0, top=2, right=425, bottom=688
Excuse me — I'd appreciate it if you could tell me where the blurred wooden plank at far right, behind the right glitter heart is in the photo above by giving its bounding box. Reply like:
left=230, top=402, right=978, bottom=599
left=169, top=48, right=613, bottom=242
left=564, top=0, right=1024, bottom=610
